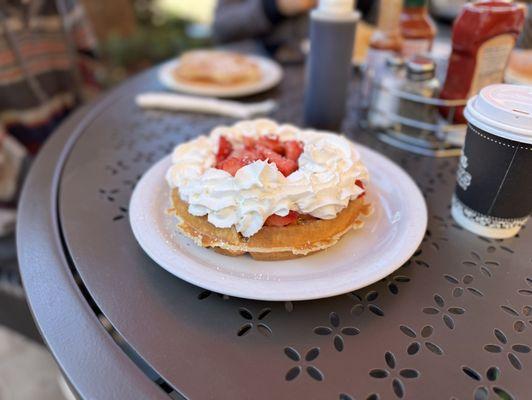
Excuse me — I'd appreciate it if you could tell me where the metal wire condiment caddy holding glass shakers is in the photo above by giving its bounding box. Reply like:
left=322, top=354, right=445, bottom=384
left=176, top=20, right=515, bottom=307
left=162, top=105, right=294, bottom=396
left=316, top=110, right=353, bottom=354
left=364, top=56, right=467, bottom=157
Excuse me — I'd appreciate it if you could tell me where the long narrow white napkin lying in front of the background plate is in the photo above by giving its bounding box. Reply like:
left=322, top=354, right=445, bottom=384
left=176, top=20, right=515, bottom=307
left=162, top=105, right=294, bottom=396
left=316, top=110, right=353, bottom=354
left=135, top=92, right=277, bottom=119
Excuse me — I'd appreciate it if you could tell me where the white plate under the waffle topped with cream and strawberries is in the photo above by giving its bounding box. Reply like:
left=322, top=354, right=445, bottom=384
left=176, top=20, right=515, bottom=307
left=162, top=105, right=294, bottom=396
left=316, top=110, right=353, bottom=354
left=129, top=145, right=427, bottom=301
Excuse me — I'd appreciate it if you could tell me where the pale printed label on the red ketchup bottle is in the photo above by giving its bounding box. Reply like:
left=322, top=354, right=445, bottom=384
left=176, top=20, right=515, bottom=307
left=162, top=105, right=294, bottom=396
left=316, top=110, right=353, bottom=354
left=467, top=34, right=515, bottom=97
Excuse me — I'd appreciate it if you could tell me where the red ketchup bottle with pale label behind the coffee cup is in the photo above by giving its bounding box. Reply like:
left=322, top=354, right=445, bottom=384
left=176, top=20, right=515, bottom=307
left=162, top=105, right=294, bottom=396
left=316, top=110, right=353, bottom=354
left=440, top=1, right=525, bottom=123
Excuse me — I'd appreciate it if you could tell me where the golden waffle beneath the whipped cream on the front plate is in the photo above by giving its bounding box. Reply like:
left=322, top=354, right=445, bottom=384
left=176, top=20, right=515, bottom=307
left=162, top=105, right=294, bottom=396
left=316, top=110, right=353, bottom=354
left=168, top=189, right=373, bottom=261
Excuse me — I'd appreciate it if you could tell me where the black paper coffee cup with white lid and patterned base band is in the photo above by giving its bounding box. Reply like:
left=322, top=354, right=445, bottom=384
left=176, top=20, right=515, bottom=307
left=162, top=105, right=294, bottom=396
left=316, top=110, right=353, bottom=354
left=451, top=84, right=532, bottom=239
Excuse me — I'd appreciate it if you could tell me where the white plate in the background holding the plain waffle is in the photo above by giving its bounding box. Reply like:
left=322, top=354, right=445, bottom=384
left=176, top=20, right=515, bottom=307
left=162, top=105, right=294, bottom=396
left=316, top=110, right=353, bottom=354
left=159, top=55, right=283, bottom=97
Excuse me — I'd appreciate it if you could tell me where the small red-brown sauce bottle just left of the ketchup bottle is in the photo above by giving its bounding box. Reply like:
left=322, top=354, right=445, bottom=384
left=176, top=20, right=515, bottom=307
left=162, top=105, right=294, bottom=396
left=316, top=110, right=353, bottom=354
left=401, top=0, right=436, bottom=58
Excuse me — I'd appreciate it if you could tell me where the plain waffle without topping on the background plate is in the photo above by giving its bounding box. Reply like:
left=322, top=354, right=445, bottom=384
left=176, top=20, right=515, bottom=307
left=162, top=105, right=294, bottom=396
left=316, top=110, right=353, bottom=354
left=174, top=50, right=261, bottom=87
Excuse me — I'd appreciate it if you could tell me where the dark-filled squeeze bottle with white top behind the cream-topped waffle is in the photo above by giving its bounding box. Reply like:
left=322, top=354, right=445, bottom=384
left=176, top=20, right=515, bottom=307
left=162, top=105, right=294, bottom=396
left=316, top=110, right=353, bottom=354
left=304, top=0, right=360, bottom=132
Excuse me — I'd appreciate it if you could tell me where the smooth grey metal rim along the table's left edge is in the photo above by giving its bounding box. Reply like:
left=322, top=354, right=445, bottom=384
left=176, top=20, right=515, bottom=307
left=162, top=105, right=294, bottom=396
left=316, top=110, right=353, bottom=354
left=16, top=74, right=168, bottom=400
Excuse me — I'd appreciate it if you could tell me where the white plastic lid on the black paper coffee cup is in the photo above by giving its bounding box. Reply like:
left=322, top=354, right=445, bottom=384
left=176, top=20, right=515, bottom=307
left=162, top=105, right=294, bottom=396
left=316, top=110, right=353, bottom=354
left=465, top=84, right=532, bottom=144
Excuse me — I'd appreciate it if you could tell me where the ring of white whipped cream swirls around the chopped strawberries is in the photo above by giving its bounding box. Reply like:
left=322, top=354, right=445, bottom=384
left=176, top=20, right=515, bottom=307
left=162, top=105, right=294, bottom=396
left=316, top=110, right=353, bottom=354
left=166, top=119, right=369, bottom=237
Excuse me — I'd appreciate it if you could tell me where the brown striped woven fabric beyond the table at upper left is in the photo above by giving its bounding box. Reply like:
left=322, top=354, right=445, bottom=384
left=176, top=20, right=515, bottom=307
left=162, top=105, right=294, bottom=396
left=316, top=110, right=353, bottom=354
left=0, top=0, right=98, bottom=234
